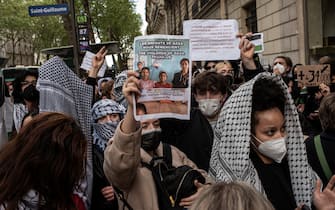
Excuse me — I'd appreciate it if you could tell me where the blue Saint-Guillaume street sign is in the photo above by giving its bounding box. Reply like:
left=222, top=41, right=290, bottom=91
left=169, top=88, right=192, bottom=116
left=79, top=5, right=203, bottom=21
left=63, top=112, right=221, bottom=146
left=28, top=4, right=69, bottom=17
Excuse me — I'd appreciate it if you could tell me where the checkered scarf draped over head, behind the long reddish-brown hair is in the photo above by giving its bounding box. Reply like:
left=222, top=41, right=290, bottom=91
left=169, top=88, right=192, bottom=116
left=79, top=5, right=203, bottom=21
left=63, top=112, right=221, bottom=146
left=37, top=56, right=93, bottom=206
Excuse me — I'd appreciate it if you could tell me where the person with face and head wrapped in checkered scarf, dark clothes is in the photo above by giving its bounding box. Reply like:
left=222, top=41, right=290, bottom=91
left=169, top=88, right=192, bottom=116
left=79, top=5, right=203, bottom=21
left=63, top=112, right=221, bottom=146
left=91, top=99, right=126, bottom=210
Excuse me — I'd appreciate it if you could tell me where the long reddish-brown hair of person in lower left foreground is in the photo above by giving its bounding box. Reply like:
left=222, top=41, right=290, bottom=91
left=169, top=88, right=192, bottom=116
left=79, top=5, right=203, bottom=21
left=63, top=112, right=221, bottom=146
left=0, top=113, right=86, bottom=210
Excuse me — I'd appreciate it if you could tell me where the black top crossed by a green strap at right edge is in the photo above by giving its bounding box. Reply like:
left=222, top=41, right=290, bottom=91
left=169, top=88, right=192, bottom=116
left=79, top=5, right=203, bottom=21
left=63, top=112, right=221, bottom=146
left=305, top=132, right=335, bottom=187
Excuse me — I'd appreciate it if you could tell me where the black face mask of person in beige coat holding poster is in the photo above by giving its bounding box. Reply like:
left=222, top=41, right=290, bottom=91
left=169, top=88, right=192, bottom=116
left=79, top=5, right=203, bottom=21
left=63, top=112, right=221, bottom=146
left=141, top=128, right=162, bottom=152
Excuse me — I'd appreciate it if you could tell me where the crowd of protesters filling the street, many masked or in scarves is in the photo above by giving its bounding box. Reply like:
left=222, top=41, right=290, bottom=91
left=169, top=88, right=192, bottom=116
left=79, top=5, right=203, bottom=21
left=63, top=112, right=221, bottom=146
left=0, top=34, right=335, bottom=210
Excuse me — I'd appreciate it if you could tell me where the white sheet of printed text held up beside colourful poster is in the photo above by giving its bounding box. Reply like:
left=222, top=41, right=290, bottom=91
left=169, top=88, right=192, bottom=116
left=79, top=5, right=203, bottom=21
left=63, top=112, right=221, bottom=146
left=183, top=19, right=240, bottom=61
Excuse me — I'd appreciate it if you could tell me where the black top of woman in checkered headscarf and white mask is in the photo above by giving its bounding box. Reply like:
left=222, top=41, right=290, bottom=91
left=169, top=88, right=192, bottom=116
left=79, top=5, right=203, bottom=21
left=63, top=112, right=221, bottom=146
left=250, top=149, right=297, bottom=210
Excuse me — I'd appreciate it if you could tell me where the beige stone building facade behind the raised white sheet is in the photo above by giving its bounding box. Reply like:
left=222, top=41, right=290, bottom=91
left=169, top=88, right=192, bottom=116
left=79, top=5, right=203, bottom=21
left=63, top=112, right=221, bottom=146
left=146, top=0, right=335, bottom=64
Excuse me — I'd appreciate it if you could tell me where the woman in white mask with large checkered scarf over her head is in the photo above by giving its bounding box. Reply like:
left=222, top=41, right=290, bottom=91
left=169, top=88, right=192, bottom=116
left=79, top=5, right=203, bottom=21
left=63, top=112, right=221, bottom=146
left=209, top=73, right=316, bottom=210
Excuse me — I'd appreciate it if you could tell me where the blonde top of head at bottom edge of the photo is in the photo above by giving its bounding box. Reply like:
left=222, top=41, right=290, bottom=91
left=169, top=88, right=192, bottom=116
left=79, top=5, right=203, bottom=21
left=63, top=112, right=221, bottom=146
left=190, top=182, right=274, bottom=210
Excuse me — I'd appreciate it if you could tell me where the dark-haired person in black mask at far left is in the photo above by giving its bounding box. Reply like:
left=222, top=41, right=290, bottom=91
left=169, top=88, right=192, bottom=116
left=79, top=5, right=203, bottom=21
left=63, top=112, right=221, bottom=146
left=13, top=70, right=39, bottom=132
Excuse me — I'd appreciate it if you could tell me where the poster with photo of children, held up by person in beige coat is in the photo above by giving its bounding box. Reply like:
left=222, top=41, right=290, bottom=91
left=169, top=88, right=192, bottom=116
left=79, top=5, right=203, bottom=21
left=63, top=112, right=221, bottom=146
left=133, top=35, right=191, bottom=120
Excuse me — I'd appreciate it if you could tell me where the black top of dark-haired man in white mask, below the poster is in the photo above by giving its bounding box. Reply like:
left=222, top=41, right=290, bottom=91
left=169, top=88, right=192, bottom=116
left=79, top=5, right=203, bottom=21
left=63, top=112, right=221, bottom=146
left=160, top=108, right=213, bottom=171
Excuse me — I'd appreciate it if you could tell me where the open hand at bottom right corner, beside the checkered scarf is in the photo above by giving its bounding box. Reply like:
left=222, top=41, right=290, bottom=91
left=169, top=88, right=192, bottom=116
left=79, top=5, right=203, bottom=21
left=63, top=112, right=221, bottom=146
left=313, top=175, right=335, bottom=210
